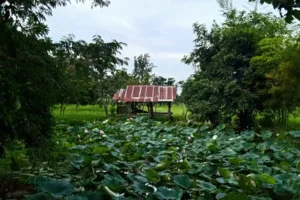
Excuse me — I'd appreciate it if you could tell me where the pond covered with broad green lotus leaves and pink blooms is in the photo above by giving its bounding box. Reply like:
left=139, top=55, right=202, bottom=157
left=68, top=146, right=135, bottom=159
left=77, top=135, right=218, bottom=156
left=1, top=118, right=300, bottom=200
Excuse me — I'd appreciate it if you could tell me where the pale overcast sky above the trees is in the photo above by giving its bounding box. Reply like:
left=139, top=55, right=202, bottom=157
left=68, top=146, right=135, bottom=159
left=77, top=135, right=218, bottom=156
left=47, top=0, right=272, bottom=81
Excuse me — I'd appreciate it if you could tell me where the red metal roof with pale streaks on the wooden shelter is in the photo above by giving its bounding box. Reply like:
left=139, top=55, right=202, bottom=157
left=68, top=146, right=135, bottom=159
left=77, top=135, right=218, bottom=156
left=113, top=85, right=176, bottom=102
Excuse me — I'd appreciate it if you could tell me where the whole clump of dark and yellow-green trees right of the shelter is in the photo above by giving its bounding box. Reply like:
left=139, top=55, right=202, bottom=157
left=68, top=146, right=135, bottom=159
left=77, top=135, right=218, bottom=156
left=181, top=5, right=300, bottom=130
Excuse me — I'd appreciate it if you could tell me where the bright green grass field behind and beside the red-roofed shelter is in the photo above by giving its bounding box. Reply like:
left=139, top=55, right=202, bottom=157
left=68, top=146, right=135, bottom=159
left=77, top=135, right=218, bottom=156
left=53, top=104, right=183, bottom=121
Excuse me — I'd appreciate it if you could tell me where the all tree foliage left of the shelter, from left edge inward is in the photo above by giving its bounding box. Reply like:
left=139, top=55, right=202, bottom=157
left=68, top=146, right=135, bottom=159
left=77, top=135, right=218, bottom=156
left=0, top=0, right=125, bottom=149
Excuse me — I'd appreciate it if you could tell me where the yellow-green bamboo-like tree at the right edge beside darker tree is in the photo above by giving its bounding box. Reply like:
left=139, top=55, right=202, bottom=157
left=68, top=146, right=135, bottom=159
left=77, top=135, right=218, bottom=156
left=251, top=34, right=300, bottom=124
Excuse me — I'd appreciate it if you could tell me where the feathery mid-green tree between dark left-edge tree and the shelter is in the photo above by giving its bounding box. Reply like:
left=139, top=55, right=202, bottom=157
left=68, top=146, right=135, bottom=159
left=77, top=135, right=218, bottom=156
left=55, top=35, right=129, bottom=116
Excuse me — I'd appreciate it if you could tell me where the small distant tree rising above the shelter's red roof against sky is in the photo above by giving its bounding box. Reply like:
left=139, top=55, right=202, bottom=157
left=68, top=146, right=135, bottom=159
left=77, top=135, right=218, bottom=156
left=132, top=54, right=155, bottom=84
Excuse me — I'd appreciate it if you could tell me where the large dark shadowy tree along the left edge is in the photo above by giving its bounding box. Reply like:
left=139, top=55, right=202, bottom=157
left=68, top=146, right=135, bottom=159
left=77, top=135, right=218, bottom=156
left=0, top=0, right=109, bottom=150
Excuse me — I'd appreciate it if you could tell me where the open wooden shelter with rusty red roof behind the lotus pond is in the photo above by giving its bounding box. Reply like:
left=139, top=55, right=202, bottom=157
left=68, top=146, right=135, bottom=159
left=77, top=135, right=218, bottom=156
left=113, top=85, right=176, bottom=120
